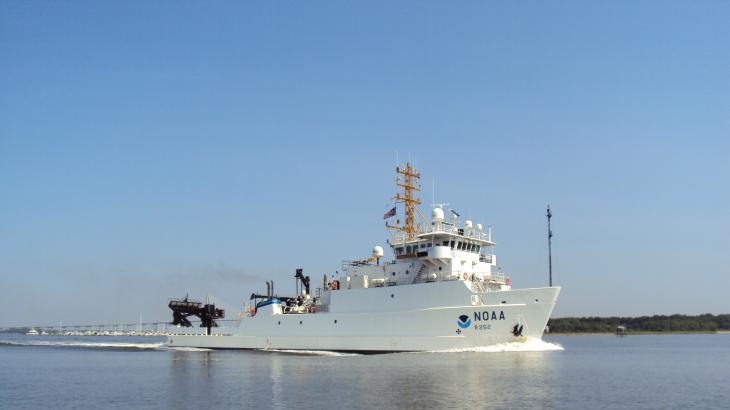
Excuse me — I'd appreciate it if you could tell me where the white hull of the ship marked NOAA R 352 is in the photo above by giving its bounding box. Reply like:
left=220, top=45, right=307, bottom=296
left=167, top=281, right=560, bottom=352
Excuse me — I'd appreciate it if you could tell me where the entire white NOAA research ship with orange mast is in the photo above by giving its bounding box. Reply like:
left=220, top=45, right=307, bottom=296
left=167, top=164, right=560, bottom=352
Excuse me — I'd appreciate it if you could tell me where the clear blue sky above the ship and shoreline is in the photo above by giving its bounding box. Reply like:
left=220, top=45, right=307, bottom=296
left=0, top=1, right=730, bottom=326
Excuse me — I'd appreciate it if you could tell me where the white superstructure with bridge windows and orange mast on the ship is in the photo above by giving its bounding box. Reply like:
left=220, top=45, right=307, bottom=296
left=343, top=165, right=510, bottom=292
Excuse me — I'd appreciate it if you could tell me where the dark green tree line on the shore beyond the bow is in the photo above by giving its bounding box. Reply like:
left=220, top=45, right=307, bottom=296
left=548, top=313, right=730, bottom=333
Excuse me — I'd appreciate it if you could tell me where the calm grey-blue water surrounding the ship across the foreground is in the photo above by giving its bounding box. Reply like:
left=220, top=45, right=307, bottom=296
left=0, top=334, right=730, bottom=409
